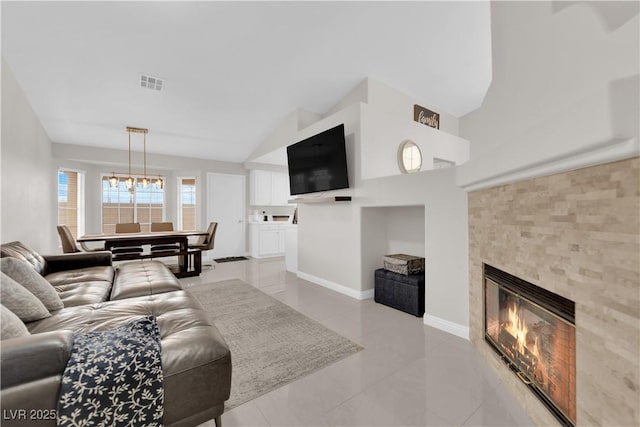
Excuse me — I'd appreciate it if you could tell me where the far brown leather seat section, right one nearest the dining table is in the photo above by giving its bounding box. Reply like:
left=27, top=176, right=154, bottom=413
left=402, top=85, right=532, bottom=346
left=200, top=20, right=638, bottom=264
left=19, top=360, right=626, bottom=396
left=110, top=261, right=182, bottom=301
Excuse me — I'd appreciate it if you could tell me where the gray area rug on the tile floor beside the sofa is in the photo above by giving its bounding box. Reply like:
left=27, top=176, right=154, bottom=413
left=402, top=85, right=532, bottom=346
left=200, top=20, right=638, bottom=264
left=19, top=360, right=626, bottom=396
left=187, top=280, right=362, bottom=411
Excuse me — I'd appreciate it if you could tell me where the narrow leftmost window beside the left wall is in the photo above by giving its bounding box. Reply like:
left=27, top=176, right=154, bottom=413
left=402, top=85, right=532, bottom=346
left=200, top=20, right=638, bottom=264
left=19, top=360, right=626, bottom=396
left=58, top=169, right=84, bottom=239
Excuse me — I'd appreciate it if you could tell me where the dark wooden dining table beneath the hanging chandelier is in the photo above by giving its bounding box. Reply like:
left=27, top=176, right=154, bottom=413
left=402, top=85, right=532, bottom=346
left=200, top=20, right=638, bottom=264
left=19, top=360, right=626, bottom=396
left=77, top=230, right=207, bottom=277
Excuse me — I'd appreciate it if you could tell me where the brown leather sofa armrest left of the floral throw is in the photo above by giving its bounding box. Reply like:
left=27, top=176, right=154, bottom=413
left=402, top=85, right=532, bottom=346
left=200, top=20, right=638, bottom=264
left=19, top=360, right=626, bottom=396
left=0, top=330, right=73, bottom=389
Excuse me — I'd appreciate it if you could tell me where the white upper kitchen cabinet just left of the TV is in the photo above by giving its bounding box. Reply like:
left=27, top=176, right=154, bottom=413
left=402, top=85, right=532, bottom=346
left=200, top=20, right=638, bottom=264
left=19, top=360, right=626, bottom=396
left=249, top=169, right=291, bottom=206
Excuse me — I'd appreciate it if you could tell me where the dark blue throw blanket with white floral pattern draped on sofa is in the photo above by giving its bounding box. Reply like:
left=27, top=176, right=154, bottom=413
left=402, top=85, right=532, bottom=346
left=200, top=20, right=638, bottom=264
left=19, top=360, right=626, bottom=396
left=57, top=316, right=164, bottom=427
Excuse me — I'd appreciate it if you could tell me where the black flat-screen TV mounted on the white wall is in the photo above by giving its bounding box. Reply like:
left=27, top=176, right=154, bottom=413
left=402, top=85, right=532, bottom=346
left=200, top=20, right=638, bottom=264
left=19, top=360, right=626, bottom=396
left=287, top=124, right=349, bottom=195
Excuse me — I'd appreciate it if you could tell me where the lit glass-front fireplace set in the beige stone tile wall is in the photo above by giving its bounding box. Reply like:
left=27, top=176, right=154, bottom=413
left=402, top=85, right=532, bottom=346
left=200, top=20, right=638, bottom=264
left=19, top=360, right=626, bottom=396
left=484, top=264, right=576, bottom=426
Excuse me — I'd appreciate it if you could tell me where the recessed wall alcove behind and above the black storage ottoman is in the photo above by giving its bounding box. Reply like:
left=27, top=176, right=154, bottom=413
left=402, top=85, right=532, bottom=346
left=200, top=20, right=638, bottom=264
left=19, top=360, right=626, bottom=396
left=361, top=205, right=428, bottom=289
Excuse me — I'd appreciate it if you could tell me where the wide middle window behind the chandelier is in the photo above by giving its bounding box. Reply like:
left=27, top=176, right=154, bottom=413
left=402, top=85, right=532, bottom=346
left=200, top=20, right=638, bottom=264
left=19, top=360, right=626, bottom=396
left=102, top=176, right=164, bottom=234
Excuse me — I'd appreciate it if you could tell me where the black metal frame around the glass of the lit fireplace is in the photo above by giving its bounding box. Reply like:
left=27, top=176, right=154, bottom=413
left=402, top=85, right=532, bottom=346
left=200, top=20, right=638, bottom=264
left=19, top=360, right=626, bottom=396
left=482, top=263, right=576, bottom=427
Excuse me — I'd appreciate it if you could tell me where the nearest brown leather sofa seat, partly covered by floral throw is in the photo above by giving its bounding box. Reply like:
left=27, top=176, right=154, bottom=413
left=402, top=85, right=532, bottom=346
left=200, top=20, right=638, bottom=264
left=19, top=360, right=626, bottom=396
left=27, top=291, right=231, bottom=425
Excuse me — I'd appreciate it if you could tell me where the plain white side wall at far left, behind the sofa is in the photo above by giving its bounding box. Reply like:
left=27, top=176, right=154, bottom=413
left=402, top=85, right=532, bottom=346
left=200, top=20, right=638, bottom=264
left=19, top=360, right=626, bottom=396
left=0, top=60, right=58, bottom=253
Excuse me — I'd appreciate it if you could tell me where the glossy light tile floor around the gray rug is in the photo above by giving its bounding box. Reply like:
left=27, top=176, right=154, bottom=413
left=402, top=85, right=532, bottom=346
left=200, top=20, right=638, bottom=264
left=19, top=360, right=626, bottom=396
left=181, top=258, right=533, bottom=427
